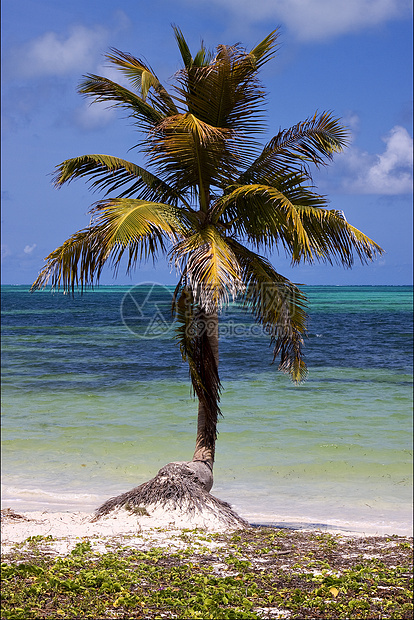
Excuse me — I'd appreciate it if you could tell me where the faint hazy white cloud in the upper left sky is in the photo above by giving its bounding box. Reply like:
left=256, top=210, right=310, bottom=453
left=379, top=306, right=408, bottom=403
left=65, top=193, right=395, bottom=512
left=14, top=25, right=108, bottom=77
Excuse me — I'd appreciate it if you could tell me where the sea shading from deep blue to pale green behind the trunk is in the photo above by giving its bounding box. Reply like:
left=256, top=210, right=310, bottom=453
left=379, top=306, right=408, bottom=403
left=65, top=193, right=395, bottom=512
left=2, top=286, right=412, bottom=533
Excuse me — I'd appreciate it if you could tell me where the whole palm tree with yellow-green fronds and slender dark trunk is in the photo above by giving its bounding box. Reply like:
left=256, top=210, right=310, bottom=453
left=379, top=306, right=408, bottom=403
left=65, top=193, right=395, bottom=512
left=32, top=26, right=382, bottom=524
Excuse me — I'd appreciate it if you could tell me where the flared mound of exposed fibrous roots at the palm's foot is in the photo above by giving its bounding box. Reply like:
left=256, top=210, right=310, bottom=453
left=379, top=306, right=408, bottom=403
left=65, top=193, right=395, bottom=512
left=93, top=461, right=250, bottom=530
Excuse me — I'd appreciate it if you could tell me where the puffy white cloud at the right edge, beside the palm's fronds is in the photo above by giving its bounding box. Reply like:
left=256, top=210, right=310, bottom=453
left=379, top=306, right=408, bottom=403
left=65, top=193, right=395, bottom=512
left=338, top=125, right=413, bottom=195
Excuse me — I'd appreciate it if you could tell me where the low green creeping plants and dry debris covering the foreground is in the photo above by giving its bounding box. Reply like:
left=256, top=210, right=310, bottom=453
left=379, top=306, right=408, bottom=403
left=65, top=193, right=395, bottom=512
left=1, top=528, right=413, bottom=620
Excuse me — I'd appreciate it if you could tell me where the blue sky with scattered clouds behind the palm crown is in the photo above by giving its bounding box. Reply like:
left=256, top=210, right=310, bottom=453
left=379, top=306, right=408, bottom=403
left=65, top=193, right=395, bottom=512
left=2, top=0, right=413, bottom=284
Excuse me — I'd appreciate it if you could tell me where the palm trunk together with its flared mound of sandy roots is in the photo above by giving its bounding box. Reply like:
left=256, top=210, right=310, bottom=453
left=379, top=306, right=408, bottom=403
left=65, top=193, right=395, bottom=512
left=94, top=310, right=249, bottom=529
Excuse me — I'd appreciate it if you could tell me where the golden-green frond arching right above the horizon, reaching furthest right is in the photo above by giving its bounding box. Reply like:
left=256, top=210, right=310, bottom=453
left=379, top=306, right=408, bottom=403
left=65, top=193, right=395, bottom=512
left=216, top=175, right=383, bottom=267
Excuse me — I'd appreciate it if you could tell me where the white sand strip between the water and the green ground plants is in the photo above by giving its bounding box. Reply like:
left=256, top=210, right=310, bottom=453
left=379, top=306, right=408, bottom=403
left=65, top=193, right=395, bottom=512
left=1, top=502, right=411, bottom=555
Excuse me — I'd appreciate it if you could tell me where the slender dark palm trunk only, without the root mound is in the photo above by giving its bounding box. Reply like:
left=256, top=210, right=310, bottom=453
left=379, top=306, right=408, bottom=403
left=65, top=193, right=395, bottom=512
left=193, top=311, right=220, bottom=472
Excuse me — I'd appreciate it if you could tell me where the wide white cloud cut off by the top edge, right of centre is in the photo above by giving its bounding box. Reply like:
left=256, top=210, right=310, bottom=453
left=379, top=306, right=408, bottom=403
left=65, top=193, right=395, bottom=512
left=201, top=0, right=411, bottom=41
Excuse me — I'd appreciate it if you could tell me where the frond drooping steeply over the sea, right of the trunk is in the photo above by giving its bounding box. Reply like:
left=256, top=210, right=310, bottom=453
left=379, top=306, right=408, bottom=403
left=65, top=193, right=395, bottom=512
left=228, top=239, right=307, bottom=383
